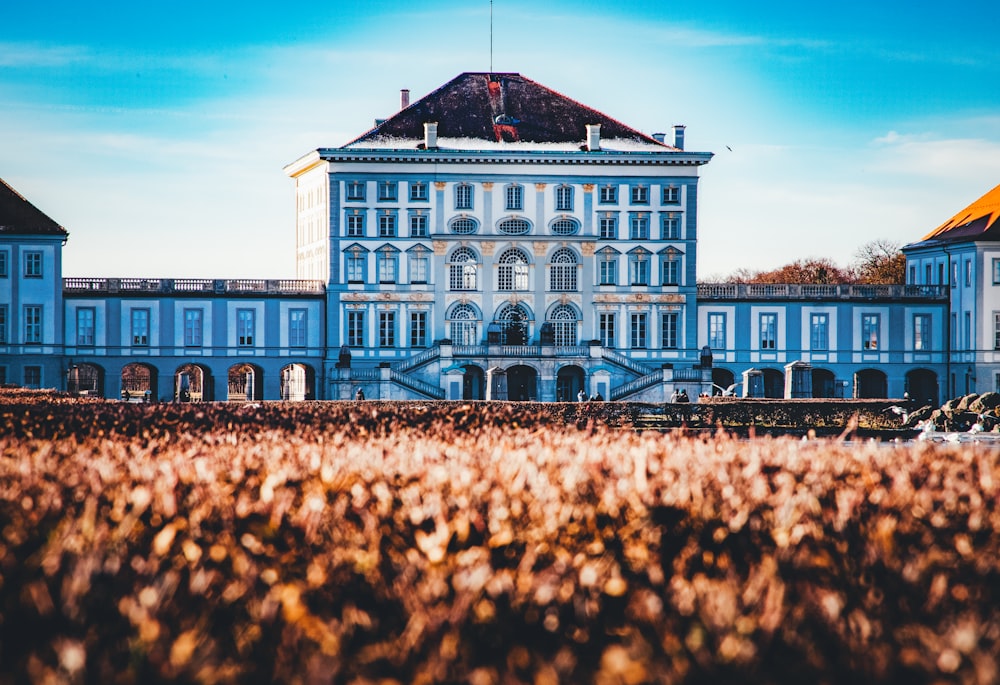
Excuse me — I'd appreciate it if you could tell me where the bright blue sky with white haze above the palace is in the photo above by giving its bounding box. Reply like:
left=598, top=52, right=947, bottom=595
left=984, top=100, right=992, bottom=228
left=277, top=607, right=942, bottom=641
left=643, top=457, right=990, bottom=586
left=0, top=0, right=1000, bottom=278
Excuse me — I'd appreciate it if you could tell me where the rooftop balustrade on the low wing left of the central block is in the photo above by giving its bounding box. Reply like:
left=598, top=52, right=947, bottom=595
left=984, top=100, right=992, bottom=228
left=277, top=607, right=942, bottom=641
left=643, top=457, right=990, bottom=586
left=63, top=278, right=325, bottom=295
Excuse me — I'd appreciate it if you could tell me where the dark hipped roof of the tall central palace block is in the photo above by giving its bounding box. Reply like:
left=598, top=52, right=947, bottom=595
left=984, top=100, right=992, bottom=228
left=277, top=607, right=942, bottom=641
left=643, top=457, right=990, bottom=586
left=344, top=72, right=674, bottom=151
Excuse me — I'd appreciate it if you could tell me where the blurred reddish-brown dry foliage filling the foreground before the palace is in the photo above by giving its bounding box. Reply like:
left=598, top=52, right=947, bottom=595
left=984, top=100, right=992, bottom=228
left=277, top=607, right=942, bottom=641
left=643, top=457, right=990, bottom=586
left=0, top=391, right=1000, bottom=685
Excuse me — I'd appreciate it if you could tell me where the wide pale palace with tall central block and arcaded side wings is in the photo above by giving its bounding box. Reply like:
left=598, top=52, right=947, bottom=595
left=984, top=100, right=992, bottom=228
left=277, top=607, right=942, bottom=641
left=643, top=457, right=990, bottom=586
left=0, top=73, right=984, bottom=402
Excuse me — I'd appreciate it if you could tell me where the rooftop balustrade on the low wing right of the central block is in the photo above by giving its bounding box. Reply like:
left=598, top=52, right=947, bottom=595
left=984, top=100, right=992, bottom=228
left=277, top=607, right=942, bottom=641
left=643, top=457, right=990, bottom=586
left=698, top=283, right=948, bottom=301
